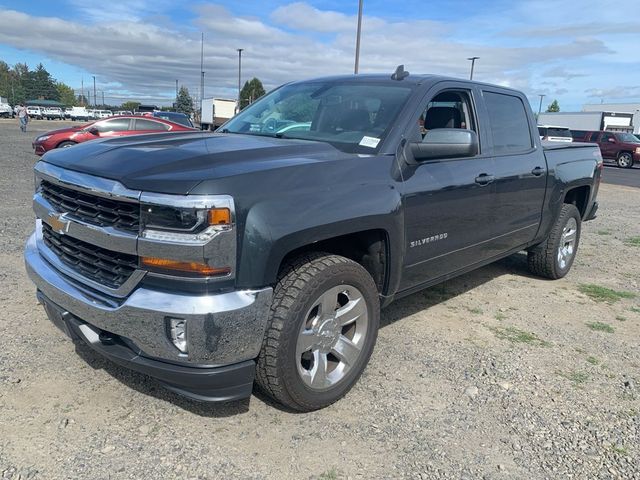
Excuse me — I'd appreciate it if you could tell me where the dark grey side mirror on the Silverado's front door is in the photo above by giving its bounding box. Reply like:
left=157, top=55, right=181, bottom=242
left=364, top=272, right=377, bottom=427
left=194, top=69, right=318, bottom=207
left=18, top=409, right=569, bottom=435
left=410, top=128, right=479, bottom=161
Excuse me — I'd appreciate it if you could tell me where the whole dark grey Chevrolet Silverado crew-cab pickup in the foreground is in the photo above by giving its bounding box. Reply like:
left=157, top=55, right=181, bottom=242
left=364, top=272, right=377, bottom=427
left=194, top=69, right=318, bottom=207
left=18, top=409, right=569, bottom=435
left=25, top=68, right=602, bottom=411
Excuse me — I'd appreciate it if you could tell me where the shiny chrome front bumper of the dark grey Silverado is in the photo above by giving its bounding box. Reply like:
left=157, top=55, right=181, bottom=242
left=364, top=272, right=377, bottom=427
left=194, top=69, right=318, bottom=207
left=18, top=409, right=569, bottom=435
left=24, top=233, right=272, bottom=367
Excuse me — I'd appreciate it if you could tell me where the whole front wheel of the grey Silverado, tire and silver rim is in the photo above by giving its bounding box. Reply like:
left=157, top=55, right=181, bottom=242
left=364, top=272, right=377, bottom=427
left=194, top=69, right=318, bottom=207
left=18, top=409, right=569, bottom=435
left=256, top=253, right=380, bottom=411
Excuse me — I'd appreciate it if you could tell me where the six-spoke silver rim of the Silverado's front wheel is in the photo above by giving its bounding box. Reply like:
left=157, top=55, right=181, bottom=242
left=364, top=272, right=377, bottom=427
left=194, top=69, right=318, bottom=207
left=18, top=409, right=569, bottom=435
left=296, top=285, right=369, bottom=390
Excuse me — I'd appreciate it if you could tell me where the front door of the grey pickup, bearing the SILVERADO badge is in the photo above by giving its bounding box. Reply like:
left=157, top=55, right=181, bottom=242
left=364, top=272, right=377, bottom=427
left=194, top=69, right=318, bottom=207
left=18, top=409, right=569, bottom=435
left=400, top=82, right=494, bottom=290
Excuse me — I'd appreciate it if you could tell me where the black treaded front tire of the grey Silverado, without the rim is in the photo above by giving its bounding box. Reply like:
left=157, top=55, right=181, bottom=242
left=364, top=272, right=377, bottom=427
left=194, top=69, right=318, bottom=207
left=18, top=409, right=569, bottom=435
left=256, top=253, right=380, bottom=412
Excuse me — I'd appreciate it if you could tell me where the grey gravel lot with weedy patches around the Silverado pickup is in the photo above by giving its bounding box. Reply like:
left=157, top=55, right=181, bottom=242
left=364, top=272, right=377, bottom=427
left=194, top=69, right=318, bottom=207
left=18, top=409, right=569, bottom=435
left=0, top=120, right=640, bottom=480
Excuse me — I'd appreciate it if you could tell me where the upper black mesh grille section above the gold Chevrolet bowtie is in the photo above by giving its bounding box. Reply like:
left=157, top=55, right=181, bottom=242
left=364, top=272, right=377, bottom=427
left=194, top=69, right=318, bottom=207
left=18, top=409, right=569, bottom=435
left=40, top=180, right=140, bottom=234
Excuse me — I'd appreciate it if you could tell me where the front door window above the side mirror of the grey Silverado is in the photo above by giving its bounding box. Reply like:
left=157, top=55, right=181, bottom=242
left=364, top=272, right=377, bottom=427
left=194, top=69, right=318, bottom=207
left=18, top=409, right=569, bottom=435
left=420, top=90, right=477, bottom=137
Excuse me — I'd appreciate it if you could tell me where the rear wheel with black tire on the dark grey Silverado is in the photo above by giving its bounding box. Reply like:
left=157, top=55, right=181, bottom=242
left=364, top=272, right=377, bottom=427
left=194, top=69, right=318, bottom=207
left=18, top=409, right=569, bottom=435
left=527, top=203, right=582, bottom=280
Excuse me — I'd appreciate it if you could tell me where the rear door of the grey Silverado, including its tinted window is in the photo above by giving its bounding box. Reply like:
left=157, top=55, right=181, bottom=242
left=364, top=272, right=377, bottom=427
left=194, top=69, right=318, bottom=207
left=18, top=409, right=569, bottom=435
left=482, top=87, right=547, bottom=251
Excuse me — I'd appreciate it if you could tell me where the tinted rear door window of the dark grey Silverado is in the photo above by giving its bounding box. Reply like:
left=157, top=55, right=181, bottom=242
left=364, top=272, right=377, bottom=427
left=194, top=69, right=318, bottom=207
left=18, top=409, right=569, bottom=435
left=484, top=92, right=533, bottom=154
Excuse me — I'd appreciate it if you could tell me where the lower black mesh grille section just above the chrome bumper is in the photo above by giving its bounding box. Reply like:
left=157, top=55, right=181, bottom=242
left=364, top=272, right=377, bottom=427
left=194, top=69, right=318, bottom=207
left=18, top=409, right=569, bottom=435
left=42, top=223, right=138, bottom=289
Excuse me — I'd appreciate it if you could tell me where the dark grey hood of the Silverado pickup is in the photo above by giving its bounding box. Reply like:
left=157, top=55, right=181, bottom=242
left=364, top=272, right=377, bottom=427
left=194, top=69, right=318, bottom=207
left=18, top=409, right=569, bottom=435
left=42, top=132, right=353, bottom=195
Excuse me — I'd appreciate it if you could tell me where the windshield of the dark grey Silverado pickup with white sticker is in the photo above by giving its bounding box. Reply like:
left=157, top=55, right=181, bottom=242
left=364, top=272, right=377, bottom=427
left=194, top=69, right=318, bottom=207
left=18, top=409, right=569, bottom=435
left=222, top=81, right=411, bottom=153
